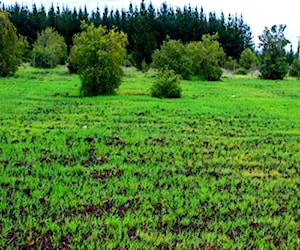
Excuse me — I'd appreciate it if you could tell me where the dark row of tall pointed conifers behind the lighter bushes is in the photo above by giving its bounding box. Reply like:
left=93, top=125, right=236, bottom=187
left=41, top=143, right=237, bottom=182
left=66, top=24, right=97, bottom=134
left=1, top=0, right=254, bottom=69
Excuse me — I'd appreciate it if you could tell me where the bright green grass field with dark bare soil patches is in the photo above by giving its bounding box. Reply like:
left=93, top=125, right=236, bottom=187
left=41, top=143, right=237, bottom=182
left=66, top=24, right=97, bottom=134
left=0, top=67, right=300, bottom=249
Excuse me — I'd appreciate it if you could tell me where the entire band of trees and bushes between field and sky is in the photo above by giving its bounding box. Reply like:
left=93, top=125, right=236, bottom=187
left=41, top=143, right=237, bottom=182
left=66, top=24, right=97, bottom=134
left=0, top=1, right=300, bottom=98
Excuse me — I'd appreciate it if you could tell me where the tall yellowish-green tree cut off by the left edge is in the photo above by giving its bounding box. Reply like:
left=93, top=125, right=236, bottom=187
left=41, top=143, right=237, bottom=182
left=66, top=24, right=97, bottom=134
left=0, top=11, right=20, bottom=77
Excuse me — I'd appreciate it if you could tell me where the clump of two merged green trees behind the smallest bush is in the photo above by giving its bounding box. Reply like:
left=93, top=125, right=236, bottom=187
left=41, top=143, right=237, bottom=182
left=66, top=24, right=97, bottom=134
left=152, top=35, right=225, bottom=81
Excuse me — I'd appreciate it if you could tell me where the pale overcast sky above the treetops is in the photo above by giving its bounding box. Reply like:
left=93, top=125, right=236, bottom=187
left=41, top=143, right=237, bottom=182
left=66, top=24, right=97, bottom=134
left=0, top=0, right=300, bottom=50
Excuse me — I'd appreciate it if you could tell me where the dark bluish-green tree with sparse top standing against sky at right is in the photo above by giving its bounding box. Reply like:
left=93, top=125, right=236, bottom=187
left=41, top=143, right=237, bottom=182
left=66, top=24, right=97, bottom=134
left=259, top=24, right=289, bottom=80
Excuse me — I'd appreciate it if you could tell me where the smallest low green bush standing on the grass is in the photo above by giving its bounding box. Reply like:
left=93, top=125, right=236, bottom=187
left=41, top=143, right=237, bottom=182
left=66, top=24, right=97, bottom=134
left=151, top=70, right=182, bottom=98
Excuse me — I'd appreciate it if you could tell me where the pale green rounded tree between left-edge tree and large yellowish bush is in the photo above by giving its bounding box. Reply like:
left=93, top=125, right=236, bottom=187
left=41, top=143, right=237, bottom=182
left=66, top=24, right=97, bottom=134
left=32, top=28, right=67, bottom=68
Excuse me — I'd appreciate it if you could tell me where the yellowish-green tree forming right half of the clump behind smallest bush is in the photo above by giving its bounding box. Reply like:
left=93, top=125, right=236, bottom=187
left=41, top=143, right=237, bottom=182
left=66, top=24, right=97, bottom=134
left=187, top=35, right=225, bottom=81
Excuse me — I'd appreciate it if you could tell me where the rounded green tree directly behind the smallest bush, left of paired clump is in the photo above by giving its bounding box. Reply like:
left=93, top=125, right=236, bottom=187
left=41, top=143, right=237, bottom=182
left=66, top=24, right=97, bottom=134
left=152, top=40, right=193, bottom=80
